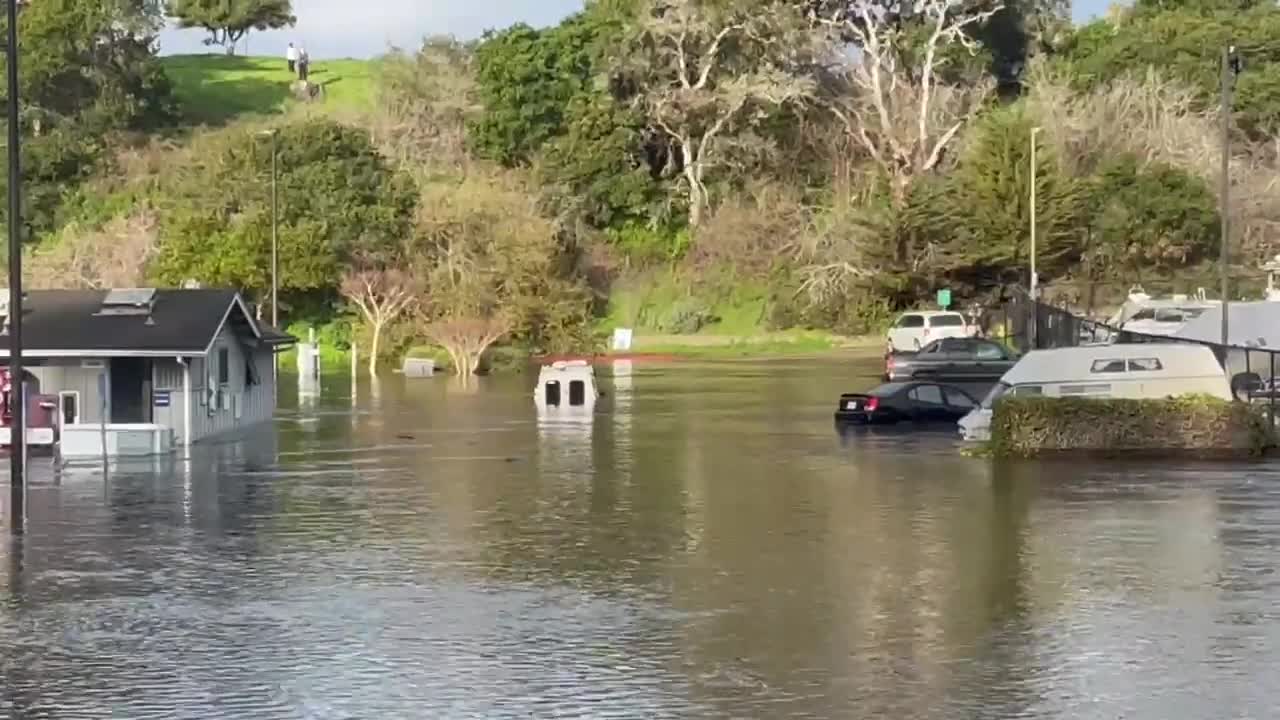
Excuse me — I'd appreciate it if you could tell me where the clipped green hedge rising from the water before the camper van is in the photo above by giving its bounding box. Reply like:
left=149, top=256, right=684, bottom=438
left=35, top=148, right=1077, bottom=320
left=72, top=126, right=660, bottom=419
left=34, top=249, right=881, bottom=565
left=991, top=396, right=1272, bottom=457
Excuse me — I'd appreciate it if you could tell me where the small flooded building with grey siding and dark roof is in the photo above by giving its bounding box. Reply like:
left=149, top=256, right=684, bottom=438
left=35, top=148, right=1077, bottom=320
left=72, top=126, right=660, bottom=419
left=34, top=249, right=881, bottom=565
left=0, top=288, right=294, bottom=456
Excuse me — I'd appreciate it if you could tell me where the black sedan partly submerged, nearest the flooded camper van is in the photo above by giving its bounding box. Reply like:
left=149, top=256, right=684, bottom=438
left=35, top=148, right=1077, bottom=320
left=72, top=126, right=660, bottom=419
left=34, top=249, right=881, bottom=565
left=836, top=382, right=978, bottom=425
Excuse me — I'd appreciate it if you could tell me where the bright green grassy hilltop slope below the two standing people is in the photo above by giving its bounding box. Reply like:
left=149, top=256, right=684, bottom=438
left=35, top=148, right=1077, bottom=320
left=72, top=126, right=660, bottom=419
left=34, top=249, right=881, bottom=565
left=161, top=54, right=375, bottom=124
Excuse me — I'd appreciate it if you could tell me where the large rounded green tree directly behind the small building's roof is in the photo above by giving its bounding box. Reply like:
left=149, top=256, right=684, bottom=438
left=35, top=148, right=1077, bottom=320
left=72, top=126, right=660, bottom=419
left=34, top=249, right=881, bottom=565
left=154, top=120, right=417, bottom=313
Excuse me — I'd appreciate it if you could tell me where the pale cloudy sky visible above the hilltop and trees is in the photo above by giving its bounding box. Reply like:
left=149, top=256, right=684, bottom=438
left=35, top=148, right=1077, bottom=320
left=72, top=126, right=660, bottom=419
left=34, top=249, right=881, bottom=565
left=160, top=0, right=1110, bottom=59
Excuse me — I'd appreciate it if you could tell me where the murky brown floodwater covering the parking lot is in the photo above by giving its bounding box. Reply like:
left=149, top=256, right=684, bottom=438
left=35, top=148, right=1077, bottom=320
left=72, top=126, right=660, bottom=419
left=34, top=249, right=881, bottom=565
left=0, top=360, right=1280, bottom=720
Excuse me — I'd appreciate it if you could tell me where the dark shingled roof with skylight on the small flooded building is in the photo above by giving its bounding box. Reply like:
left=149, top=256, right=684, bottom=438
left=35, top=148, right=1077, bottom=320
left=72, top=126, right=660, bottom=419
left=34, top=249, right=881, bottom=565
left=0, top=288, right=293, bottom=355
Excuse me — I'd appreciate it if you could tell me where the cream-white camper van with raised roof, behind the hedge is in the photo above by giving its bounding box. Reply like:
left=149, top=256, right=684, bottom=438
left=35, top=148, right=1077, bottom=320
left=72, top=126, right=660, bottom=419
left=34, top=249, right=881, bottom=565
left=960, top=343, right=1231, bottom=441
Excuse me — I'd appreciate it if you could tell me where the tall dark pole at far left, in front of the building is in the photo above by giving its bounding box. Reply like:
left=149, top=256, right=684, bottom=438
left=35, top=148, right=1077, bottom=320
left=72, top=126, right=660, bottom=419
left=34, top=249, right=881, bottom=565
left=5, top=0, right=27, bottom=504
